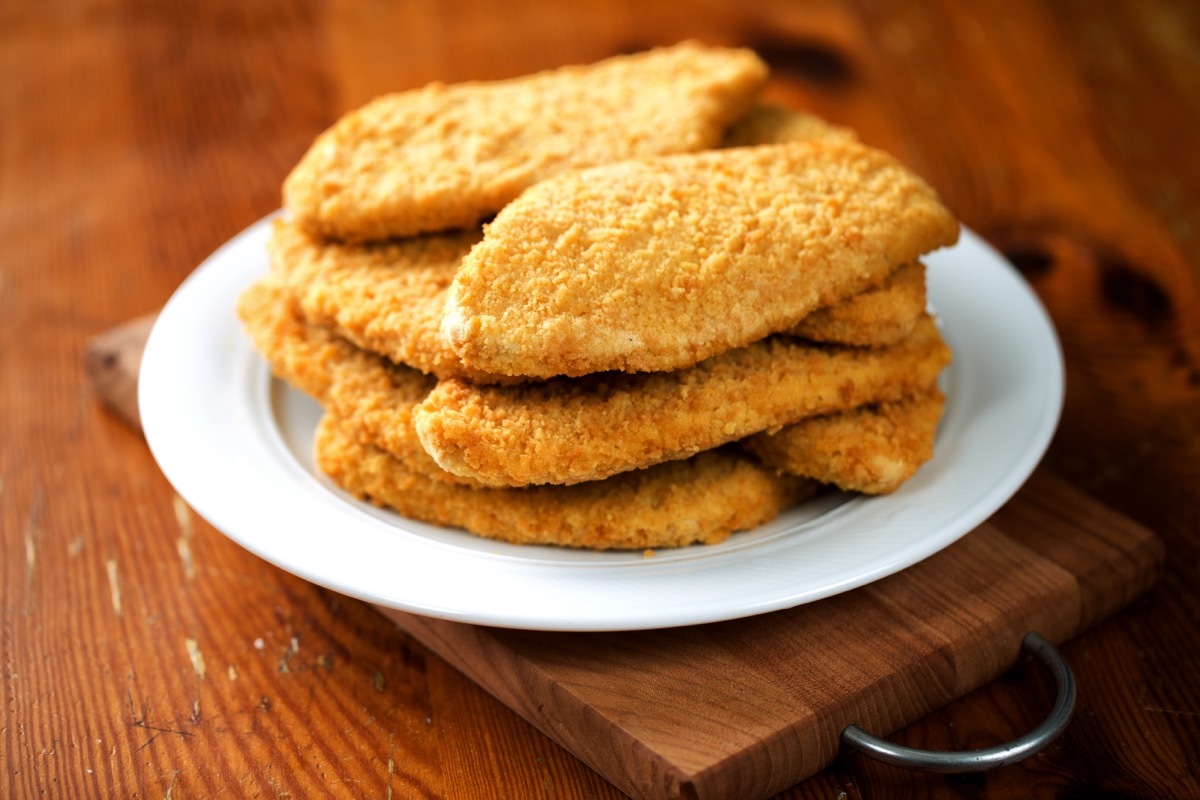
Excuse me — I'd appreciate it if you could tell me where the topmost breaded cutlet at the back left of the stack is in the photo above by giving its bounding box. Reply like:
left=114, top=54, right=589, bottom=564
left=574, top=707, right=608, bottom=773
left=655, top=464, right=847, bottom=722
left=283, top=42, right=767, bottom=240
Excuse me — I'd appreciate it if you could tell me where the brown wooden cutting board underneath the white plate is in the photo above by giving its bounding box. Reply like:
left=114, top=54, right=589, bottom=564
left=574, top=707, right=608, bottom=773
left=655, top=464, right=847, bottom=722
left=88, top=318, right=1163, bottom=800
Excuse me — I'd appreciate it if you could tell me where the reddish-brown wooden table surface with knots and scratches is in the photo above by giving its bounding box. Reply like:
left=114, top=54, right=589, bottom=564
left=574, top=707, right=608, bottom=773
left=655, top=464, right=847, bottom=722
left=0, top=0, right=1200, bottom=799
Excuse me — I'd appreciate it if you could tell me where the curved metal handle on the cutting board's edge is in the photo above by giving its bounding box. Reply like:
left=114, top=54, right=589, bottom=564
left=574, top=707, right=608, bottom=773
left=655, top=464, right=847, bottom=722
left=841, top=631, right=1075, bottom=774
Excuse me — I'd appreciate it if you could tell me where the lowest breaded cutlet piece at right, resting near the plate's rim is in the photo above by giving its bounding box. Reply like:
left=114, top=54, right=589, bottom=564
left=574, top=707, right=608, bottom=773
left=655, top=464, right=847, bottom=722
left=742, top=386, right=946, bottom=494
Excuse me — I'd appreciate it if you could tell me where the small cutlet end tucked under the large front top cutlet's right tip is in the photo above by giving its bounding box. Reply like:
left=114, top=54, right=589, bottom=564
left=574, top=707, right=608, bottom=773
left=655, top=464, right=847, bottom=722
left=787, top=261, right=925, bottom=347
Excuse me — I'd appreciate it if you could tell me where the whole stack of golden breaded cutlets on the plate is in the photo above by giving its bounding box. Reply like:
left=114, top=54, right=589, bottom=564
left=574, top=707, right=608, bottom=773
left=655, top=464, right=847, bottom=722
left=239, top=42, right=958, bottom=549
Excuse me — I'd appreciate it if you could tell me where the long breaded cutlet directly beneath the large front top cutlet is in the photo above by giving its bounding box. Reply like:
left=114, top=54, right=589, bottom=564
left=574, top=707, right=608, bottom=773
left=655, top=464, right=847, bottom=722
left=413, top=317, right=950, bottom=486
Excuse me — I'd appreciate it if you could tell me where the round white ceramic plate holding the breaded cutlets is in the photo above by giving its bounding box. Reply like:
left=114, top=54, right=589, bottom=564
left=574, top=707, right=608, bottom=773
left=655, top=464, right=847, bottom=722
left=139, top=221, right=1063, bottom=631
